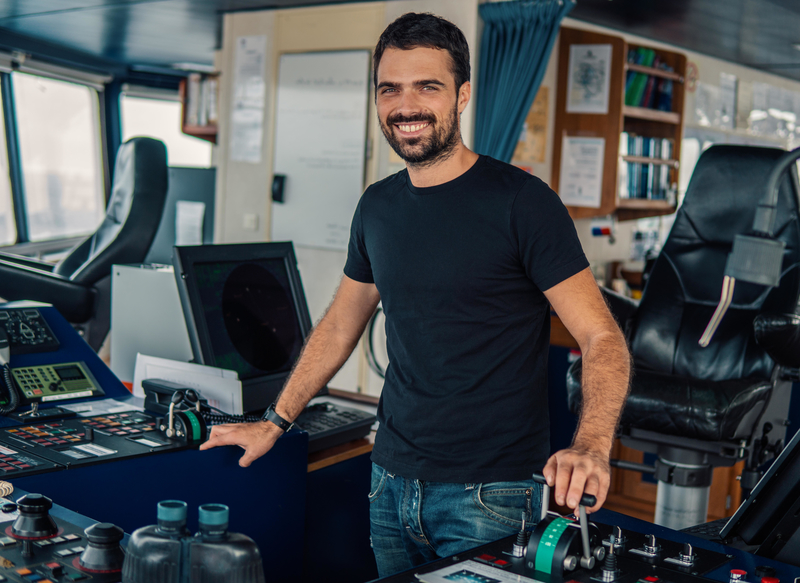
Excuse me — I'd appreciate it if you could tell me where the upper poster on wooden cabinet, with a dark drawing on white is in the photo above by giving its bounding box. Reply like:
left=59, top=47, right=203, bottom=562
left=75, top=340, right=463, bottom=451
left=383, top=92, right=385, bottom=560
left=567, top=45, right=611, bottom=114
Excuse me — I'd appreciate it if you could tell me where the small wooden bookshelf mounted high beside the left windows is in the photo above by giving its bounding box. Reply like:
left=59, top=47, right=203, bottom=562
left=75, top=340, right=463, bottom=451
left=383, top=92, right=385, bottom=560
left=179, top=73, right=219, bottom=144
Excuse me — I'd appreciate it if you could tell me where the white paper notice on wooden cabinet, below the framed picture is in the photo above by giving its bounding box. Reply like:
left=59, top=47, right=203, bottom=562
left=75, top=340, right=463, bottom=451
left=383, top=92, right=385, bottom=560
left=558, top=137, right=606, bottom=208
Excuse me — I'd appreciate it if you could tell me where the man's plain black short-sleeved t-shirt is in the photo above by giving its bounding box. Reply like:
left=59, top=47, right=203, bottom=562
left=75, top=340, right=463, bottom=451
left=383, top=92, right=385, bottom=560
left=344, top=156, right=588, bottom=483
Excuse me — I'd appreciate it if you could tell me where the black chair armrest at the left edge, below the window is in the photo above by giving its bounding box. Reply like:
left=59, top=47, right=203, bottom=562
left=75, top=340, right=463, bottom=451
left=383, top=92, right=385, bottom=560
left=0, top=259, right=97, bottom=323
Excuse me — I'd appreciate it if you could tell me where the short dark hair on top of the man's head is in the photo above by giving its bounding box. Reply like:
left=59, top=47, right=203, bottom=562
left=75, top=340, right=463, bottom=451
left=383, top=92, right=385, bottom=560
left=372, top=12, right=470, bottom=90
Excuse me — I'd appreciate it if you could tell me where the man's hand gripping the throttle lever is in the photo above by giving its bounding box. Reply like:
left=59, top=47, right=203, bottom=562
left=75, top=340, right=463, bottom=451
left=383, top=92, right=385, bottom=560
left=542, top=447, right=611, bottom=512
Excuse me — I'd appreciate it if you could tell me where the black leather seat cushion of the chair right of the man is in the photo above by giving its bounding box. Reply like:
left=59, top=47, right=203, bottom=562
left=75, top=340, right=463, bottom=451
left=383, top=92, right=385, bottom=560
left=567, top=359, right=772, bottom=441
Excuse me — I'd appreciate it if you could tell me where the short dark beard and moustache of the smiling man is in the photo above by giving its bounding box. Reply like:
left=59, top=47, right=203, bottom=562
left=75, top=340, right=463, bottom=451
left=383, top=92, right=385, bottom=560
left=378, top=105, right=461, bottom=168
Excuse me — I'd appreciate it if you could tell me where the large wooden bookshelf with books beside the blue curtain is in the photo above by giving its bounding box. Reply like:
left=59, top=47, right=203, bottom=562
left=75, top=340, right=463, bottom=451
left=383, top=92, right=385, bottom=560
left=552, top=27, right=686, bottom=221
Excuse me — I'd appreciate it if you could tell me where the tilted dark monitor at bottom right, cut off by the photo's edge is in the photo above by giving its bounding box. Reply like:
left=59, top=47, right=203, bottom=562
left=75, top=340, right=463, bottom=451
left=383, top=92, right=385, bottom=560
left=720, top=424, right=800, bottom=565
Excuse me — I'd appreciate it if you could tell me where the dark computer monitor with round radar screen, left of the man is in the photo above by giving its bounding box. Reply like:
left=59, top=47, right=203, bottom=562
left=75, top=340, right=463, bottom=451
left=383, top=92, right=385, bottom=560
left=173, top=242, right=327, bottom=412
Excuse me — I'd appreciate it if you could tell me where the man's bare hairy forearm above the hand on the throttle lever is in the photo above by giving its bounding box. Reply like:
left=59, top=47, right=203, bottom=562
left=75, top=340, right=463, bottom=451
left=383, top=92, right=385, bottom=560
left=573, top=329, right=631, bottom=459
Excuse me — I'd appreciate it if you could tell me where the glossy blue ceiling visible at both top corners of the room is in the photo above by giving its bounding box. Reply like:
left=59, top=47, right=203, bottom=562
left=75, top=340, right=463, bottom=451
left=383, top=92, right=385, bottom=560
left=0, top=0, right=800, bottom=81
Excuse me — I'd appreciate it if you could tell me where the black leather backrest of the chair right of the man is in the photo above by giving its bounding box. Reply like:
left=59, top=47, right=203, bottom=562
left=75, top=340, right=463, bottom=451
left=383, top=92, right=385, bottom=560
left=629, top=145, right=800, bottom=381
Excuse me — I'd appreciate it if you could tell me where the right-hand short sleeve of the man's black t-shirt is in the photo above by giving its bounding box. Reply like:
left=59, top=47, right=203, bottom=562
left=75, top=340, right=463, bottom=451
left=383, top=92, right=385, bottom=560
left=511, top=179, right=589, bottom=291
